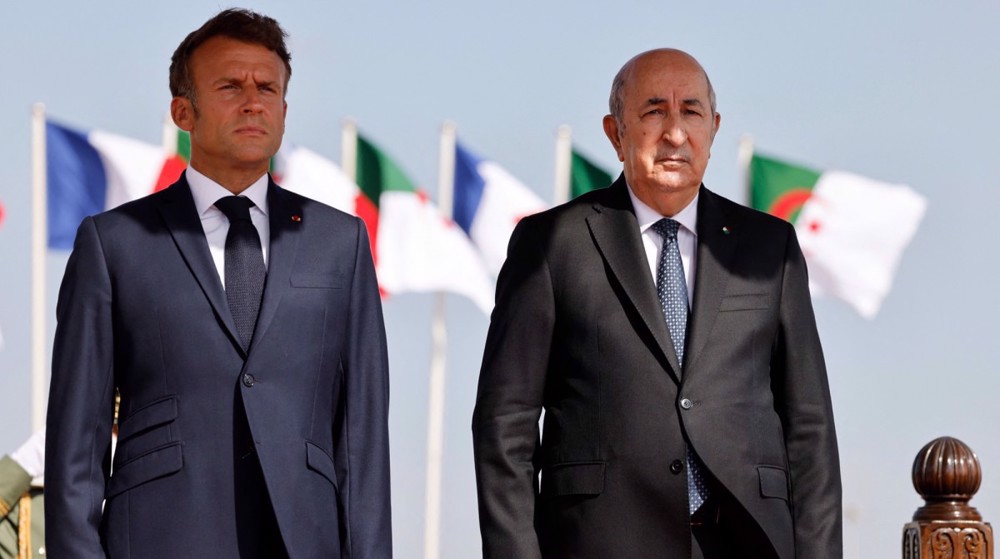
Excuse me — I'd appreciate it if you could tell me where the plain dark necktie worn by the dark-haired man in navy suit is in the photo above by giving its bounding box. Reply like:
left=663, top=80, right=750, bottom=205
left=215, top=196, right=267, bottom=351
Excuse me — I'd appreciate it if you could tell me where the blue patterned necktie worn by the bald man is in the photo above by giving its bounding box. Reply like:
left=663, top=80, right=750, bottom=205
left=653, top=218, right=708, bottom=514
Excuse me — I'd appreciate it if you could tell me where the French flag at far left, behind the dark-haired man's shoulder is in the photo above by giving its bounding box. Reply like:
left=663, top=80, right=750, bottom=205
left=45, top=120, right=178, bottom=249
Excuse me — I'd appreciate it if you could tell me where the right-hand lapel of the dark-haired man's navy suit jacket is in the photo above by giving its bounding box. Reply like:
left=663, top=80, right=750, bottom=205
left=250, top=179, right=302, bottom=353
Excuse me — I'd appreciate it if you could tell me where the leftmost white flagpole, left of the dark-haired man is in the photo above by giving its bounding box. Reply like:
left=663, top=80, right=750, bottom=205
left=31, top=103, right=48, bottom=431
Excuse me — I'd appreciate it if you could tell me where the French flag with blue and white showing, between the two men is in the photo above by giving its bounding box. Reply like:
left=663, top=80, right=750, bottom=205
left=452, top=141, right=547, bottom=276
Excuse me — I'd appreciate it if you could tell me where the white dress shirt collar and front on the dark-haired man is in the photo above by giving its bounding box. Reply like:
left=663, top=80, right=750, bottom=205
left=184, top=166, right=271, bottom=286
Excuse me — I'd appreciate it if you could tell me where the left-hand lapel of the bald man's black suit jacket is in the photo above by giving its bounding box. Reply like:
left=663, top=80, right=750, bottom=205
left=587, top=176, right=681, bottom=382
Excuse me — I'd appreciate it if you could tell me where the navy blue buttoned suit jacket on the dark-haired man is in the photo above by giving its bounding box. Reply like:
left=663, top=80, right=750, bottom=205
left=45, top=176, right=391, bottom=559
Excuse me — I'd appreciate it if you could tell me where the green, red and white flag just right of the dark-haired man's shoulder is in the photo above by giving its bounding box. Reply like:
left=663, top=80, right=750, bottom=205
left=356, top=135, right=493, bottom=314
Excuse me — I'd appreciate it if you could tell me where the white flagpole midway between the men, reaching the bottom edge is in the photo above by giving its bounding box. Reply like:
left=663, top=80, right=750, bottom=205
left=424, top=121, right=455, bottom=559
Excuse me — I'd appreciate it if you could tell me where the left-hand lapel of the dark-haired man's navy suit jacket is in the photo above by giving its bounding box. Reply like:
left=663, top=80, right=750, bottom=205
left=160, top=177, right=243, bottom=353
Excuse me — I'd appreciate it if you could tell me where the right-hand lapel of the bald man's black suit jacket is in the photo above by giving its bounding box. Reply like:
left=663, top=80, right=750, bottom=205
left=685, top=186, right=740, bottom=373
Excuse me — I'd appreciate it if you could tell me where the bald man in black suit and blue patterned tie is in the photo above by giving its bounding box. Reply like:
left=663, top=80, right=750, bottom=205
left=473, top=49, right=841, bottom=559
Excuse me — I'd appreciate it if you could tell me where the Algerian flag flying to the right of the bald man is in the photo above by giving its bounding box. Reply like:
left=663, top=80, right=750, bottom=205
left=749, top=154, right=927, bottom=319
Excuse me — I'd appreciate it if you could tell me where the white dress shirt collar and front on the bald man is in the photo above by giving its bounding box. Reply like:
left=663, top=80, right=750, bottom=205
left=628, top=186, right=699, bottom=308
